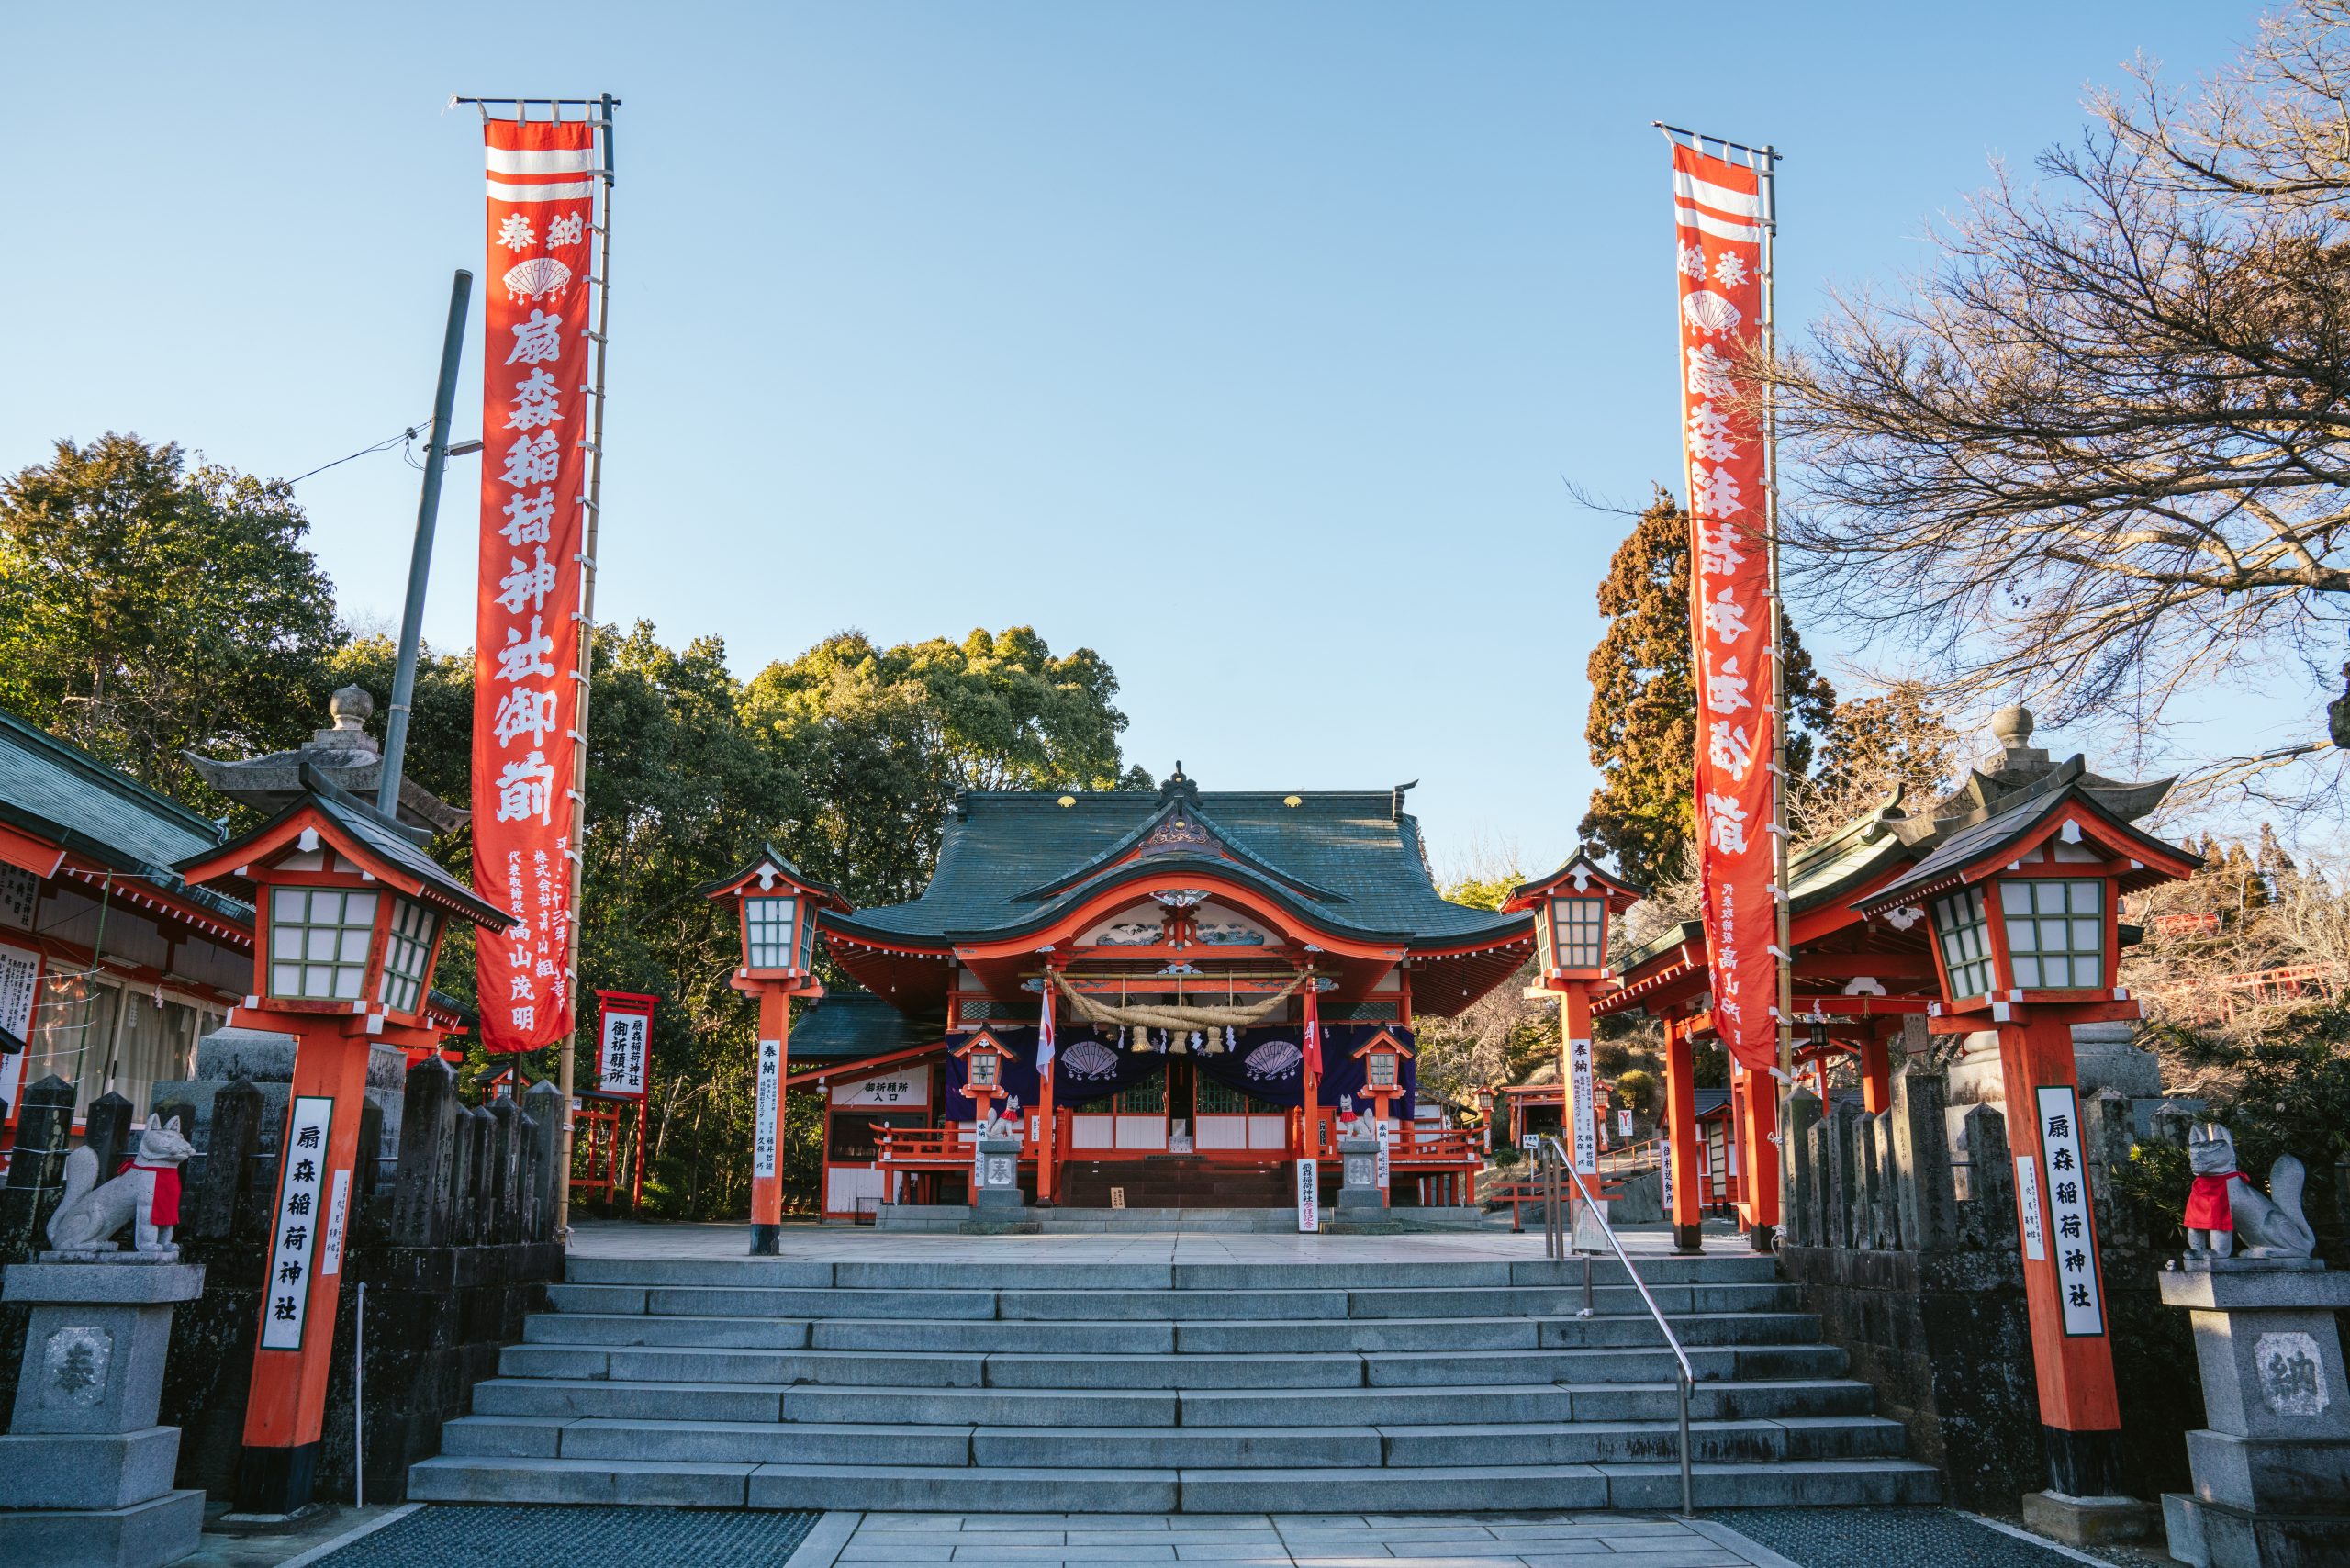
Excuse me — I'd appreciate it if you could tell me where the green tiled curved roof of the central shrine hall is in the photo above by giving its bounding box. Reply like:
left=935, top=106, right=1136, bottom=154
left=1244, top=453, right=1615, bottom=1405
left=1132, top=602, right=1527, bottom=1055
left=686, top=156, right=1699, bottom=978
left=825, top=790, right=1528, bottom=943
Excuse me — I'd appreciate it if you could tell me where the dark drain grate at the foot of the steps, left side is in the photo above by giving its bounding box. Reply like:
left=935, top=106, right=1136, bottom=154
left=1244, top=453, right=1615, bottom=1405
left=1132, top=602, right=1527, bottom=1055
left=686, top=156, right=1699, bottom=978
left=318, top=1502, right=822, bottom=1568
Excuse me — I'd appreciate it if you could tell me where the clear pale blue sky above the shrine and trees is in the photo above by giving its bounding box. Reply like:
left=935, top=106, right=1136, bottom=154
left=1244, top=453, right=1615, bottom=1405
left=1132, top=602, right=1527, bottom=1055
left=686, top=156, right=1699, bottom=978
left=0, top=0, right=2291, bottom=869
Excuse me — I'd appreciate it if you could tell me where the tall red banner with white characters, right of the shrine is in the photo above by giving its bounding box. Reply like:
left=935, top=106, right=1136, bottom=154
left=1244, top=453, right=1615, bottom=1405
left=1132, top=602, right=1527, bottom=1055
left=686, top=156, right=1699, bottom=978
left=1673, top=141, right=1779, bottom=1072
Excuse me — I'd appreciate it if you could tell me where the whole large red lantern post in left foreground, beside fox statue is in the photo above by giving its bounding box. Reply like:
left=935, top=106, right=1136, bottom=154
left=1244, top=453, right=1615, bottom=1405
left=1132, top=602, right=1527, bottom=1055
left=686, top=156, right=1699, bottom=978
left=179, top=767, right=508, bottom=1514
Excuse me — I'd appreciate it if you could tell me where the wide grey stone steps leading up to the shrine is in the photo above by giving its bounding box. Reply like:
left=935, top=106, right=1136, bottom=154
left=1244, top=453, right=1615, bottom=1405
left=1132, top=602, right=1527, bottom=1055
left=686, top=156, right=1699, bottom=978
left=408, top=1253, right=1936, bottom=1512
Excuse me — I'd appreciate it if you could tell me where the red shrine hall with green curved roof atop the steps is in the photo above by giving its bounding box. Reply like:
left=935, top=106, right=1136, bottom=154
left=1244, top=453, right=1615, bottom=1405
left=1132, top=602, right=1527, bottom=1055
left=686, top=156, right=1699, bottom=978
left=785, top=767, right=1535, bottom=1215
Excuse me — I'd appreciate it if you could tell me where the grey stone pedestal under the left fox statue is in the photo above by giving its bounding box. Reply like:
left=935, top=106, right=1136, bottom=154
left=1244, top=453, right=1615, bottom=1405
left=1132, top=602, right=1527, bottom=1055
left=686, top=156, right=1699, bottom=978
left=0, top=1253, right=205, bottom=1568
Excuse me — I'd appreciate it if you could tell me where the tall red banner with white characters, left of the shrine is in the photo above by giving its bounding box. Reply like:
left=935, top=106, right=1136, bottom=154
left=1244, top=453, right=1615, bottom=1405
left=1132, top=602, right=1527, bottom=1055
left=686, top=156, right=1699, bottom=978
left=473, top=120, right=597, bottom=1051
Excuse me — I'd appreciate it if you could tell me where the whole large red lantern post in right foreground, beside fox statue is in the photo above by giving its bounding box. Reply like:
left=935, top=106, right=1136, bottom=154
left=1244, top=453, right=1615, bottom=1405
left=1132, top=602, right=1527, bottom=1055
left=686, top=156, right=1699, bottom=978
left=1856, top=780, right=2198, bottom=1497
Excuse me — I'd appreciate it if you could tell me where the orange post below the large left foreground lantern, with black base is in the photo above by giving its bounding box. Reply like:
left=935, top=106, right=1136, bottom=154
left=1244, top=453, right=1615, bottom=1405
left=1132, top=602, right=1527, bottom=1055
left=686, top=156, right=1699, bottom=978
left=232, top=1014, right=369, bottom=1514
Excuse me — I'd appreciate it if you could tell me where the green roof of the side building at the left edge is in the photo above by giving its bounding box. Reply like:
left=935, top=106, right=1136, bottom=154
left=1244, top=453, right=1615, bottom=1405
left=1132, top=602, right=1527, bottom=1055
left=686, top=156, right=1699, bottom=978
left=0, top=712, right=252, bottom=919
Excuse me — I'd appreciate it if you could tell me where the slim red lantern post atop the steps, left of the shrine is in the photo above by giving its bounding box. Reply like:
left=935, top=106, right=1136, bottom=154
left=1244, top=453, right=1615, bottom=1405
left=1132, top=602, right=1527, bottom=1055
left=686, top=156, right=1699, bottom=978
left=702, top=844, right=846, bottom=1258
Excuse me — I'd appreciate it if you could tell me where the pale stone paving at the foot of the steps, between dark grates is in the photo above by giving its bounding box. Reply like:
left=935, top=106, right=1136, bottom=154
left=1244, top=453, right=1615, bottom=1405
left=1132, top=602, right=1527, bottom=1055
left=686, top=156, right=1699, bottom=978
left=792, top=1514, right=1788, bottom=1568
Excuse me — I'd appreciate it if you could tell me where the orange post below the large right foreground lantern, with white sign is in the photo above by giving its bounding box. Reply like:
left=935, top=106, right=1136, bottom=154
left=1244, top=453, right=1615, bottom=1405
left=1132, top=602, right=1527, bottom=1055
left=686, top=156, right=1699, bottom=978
left=2000, top=1014, right=2124, bottom=1497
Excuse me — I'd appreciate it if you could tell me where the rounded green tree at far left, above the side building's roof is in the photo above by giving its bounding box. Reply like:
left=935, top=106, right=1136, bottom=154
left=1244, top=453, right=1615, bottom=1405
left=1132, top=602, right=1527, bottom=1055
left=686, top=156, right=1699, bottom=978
left=0, top=435, right=341, bottom=809
